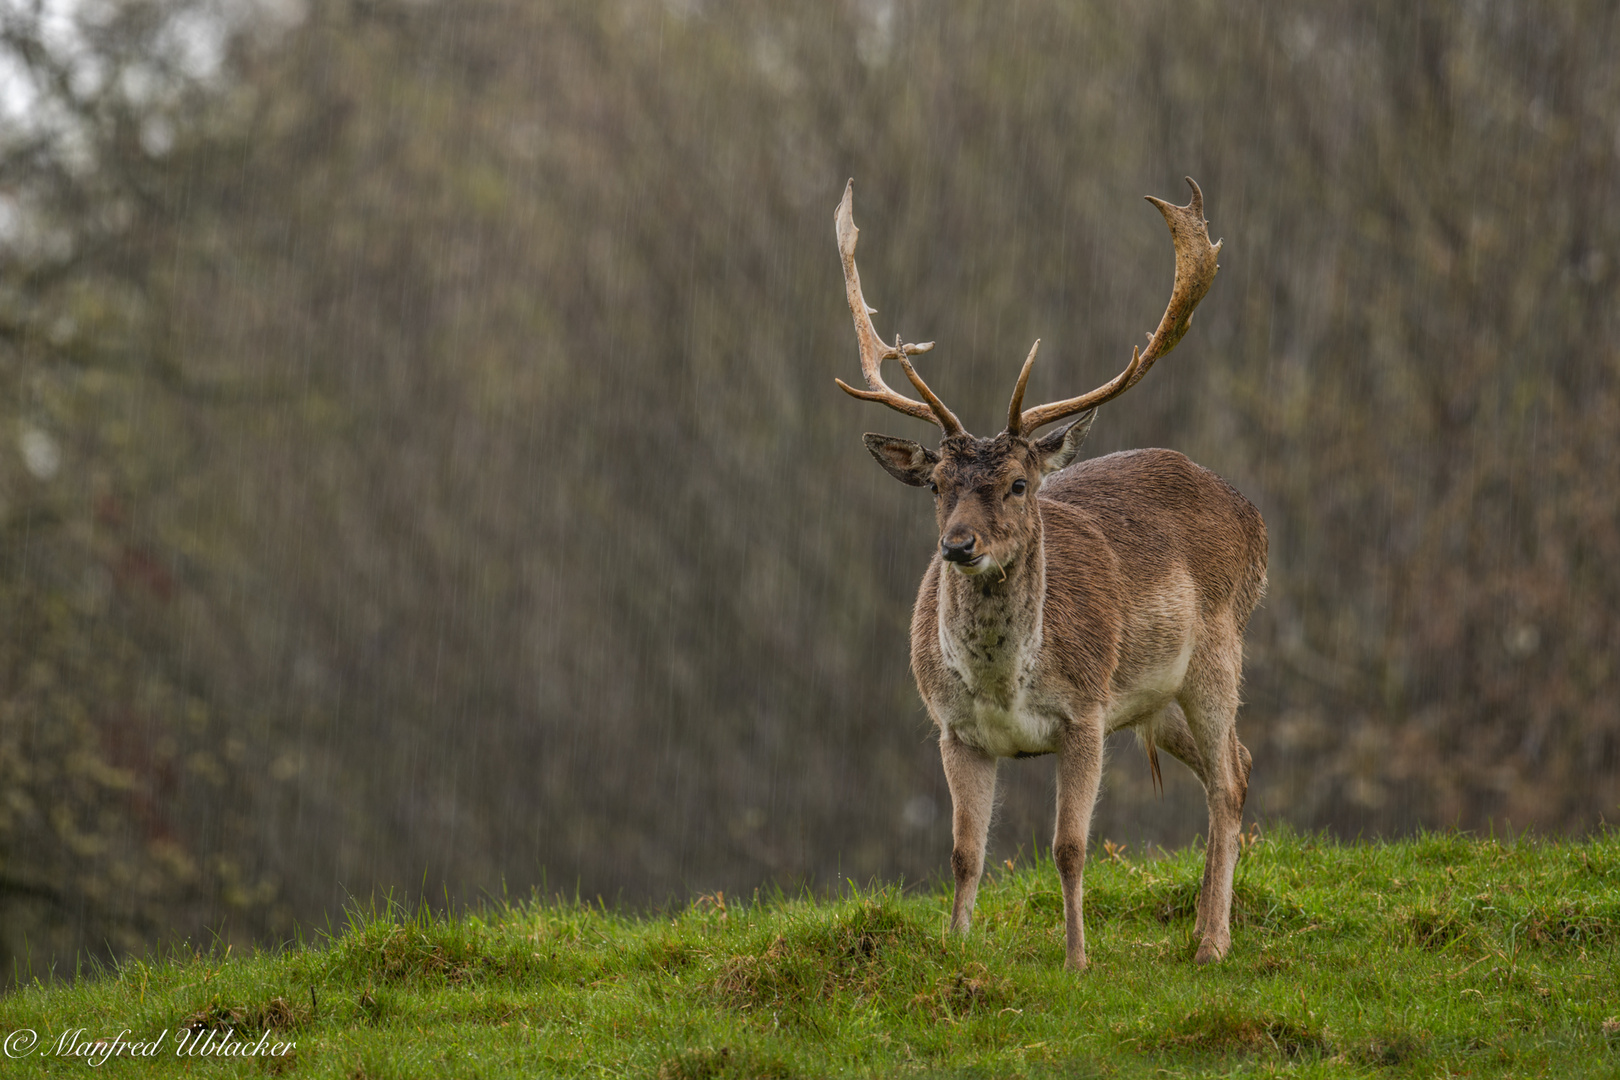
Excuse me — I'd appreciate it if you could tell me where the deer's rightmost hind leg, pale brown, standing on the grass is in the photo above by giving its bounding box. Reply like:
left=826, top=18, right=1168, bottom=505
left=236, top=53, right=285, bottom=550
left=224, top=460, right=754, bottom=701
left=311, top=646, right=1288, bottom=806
left=1166, top=650, right=1249, bottom=963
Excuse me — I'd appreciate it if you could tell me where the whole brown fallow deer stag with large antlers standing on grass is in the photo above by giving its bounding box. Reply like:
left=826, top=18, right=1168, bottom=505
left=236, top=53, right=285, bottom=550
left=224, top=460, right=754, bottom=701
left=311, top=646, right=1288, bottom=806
left=836, top=176, right=1267, bottom=968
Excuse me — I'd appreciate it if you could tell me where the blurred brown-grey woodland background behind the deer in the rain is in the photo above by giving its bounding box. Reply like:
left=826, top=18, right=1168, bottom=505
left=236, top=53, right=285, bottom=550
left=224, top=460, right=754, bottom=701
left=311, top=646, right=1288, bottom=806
left=0, top=0, right=1620, bottom=976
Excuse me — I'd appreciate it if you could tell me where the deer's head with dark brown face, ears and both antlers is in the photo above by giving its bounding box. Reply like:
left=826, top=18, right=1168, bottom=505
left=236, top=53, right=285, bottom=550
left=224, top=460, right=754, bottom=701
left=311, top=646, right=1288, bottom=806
left=836, top=176, right=1220, bottom=575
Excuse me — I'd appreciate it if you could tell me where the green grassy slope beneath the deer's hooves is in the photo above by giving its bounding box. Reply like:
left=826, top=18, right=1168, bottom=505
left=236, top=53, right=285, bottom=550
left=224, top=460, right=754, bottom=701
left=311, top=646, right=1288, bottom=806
left=0, top=831, right=1620, bottom=1078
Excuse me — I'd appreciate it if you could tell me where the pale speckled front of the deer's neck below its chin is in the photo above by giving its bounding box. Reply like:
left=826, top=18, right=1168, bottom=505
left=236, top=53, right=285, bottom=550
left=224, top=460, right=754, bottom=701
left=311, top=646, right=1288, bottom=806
left=938, top=529, right=1047, bottom=708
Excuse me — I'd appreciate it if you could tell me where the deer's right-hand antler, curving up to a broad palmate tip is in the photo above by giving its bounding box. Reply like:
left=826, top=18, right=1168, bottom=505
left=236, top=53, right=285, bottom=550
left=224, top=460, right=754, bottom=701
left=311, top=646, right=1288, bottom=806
left=1004, top=176, right=1220, bottom=436
